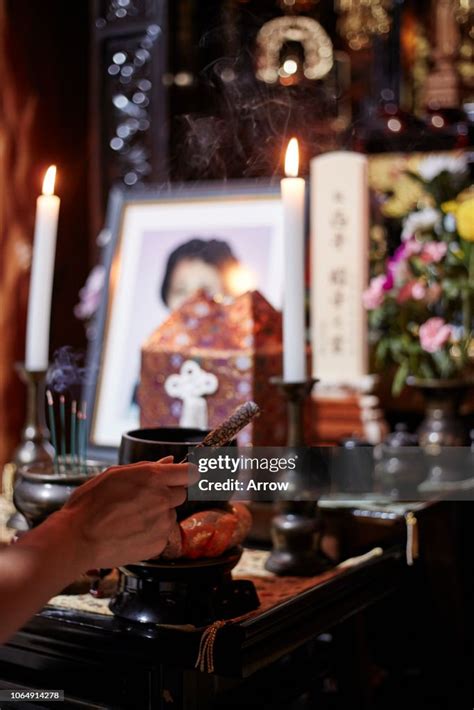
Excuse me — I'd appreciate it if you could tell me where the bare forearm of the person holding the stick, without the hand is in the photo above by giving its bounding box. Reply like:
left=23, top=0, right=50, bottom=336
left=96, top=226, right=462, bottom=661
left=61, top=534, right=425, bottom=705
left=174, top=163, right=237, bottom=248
left=0, top=512, right=90, bottom=643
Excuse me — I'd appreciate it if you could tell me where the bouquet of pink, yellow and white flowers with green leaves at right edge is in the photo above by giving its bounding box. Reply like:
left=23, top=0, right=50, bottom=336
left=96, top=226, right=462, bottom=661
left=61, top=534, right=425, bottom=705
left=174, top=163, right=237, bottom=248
left=363, top=156, right=474, bottom=394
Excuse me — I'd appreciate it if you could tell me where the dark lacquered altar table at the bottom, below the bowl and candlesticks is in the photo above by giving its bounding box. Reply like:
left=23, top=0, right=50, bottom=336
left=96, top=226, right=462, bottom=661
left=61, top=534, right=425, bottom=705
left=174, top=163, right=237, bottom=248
left=0, top=504, right=473, bottom=710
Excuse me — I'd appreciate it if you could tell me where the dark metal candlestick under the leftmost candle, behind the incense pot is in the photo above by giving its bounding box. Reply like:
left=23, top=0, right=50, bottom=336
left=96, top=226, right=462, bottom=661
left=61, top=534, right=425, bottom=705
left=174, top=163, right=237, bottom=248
left=7, top=363, right=54, bottom=530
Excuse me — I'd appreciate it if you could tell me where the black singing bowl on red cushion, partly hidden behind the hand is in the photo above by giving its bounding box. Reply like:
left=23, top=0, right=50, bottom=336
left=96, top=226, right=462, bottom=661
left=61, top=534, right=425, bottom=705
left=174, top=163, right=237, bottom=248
left=119, top=427, right=232, bottom=520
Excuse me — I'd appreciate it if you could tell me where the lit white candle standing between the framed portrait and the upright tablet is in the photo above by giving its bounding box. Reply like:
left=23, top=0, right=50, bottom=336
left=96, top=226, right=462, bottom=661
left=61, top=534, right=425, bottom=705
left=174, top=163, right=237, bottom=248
left=281, top=138, right=306, bottom=382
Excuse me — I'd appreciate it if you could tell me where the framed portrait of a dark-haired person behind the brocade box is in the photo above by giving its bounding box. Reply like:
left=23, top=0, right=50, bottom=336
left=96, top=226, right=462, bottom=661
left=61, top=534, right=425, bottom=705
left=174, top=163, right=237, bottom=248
left=87, top=183, right=283, bottom=449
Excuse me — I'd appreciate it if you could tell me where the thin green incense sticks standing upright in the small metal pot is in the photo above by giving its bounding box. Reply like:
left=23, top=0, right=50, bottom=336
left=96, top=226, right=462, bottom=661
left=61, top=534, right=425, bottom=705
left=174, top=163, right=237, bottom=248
left=46, top=390, right=87, bottom=474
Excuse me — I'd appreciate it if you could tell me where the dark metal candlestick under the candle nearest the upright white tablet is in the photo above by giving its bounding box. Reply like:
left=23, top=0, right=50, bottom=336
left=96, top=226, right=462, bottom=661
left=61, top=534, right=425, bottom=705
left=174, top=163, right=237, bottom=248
left=265, top=378, right=327, bottom=577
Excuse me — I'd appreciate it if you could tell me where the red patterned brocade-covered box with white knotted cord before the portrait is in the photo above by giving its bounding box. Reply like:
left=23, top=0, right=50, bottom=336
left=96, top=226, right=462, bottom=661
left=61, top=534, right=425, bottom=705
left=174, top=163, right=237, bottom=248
left=138, top=291, right=286, bottom=446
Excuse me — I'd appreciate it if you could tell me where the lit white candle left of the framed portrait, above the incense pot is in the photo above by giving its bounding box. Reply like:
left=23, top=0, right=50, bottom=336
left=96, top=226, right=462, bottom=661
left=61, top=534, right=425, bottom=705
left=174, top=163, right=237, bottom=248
left=25, top=165, right=60, bottom=370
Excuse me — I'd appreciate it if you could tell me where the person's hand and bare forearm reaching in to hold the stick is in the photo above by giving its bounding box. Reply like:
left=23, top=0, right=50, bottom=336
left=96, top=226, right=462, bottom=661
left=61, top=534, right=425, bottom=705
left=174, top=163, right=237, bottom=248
left=0, top=457, right=193, bottom=643
